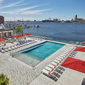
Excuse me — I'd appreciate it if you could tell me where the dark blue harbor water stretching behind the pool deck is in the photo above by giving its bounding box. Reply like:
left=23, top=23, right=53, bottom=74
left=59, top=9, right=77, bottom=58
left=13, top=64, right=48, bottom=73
left=13, top=22, right=85, bottom=42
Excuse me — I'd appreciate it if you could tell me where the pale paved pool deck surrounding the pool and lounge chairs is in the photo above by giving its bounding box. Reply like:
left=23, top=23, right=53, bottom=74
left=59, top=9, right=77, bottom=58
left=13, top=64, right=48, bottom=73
left=0, top=37, right=85, bottom=85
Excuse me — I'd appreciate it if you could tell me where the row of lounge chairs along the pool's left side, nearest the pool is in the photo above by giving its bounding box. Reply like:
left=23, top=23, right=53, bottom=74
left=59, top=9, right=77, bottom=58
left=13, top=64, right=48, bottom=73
left=0, top=40, right=35, bottom=53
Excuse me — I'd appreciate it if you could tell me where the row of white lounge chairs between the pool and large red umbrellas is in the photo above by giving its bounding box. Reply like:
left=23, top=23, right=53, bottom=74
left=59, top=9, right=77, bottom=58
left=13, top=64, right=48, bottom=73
left=42, top=47, right=73, bottom=81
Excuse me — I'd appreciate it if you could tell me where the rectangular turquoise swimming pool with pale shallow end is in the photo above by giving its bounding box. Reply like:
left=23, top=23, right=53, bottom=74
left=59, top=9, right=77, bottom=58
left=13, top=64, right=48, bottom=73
left=14, top=41, right=64, bottom=66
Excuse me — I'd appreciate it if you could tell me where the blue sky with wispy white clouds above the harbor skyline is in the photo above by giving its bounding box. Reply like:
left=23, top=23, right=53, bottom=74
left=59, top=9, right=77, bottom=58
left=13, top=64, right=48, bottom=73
left=0, top=0, right=85, bottom=21
